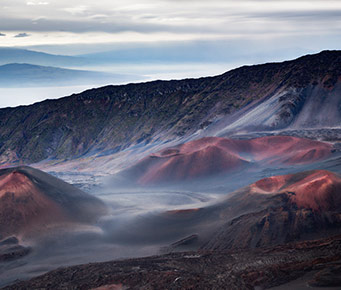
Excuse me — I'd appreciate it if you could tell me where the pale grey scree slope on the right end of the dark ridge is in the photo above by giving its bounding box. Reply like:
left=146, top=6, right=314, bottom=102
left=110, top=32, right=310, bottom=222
left=210, top=82, right=341, bottom=136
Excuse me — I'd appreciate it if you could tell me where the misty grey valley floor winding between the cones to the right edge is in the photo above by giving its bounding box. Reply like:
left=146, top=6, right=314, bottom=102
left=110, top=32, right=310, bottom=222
left=0, top=151, right=340, bottom=286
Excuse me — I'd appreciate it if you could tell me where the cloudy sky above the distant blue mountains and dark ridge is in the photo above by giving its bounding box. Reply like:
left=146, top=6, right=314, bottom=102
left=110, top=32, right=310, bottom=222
left=0, top=0, right=341, bottom=106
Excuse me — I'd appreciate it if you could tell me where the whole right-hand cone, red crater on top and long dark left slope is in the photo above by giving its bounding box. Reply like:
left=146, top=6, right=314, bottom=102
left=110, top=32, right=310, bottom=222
left=110, top=170, right=341, bottom=251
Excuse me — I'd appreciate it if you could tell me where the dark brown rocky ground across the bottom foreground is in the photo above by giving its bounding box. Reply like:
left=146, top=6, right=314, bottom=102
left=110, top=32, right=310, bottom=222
left=4, top=236, right=341, bottom=289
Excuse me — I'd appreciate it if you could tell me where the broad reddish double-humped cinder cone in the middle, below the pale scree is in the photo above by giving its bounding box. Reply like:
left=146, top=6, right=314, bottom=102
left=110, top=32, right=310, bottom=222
left=132, top=136, right=332, bottom=184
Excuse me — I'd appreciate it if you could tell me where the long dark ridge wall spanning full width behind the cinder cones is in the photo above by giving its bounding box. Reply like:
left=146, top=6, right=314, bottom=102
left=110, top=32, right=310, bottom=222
left=0, top=51, right=341, bottom=167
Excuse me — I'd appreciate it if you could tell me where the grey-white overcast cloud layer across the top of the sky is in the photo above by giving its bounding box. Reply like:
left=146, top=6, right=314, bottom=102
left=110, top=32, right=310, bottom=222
left=0, top=0, right=341, bottom=46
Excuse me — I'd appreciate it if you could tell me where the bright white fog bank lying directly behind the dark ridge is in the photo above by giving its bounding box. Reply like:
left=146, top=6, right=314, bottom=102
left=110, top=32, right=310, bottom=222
left=0, top=63, right=231, bottom=108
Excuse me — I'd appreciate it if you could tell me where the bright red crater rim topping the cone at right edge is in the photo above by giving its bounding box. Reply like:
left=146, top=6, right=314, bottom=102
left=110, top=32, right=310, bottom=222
left=251, top=170, right=341, bottom=211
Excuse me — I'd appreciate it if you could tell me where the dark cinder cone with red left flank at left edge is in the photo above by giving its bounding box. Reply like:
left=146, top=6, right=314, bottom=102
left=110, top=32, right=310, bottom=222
left=0, top=167, right=106, bottom=239
